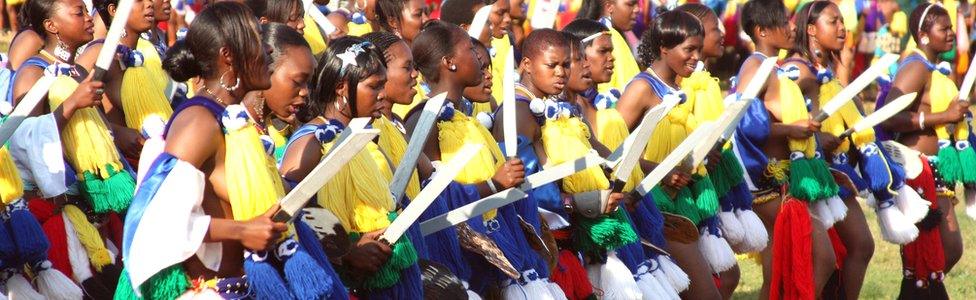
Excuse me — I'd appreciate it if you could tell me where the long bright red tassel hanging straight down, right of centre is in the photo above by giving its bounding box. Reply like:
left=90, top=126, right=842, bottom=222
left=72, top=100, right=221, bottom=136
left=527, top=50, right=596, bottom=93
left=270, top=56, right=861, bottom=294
left=769, top=197, right=816, bottom=299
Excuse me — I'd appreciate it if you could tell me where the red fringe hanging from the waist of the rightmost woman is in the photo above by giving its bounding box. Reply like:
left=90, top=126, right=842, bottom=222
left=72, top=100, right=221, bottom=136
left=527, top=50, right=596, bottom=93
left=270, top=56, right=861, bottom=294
left=902, top=157, right=945, bottom=282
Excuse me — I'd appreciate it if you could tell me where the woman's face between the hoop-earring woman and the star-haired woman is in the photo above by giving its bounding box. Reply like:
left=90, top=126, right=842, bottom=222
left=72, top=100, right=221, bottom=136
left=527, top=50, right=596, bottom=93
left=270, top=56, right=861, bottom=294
left=262, top=46, right=315, bottom=123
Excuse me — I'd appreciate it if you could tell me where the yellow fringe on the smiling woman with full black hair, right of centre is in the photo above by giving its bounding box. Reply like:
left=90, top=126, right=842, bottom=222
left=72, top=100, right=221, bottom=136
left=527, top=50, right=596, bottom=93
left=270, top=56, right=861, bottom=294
left=681, top=70, right=725, bottom=123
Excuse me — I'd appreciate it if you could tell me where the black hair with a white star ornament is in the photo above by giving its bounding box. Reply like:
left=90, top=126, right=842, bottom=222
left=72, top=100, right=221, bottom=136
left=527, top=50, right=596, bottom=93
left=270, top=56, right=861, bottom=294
left=304, top=36, right=386, bottom=123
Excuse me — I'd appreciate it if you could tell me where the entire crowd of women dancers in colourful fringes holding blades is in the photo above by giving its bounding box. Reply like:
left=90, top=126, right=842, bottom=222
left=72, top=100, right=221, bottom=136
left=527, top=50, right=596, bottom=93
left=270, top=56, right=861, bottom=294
left=0, top=0, right=976, bottom=299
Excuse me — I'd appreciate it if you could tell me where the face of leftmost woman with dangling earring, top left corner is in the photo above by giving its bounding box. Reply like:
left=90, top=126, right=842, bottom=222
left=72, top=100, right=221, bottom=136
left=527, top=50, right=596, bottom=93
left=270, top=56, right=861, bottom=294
left=48, top=0, right=95, bottom=47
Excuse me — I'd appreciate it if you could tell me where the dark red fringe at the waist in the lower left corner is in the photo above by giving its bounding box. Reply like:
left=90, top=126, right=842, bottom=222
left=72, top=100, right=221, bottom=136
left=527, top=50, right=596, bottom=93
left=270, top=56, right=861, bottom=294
left=27, top=199, right=73, bottom=278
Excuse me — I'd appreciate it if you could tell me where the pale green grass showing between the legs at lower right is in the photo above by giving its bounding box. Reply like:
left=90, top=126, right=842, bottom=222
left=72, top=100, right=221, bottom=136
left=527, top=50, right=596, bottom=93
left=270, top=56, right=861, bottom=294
left=732, top=203, right=976, bottom=299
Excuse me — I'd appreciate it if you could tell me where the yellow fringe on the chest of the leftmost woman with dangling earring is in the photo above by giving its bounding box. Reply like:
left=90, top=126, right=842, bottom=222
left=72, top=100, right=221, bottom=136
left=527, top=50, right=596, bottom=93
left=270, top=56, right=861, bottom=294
left=48, top=76, right=123, bottom=179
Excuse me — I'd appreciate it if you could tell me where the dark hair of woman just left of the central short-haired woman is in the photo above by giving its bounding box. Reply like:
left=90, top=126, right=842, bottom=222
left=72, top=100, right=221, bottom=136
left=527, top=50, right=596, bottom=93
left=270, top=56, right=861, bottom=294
left=410, top=21, right=470, bottom=82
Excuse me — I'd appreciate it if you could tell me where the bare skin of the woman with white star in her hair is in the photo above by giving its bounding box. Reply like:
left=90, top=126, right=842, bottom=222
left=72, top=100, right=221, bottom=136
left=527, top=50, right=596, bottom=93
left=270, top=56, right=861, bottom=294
left=281, top=68, right=392, bottom=280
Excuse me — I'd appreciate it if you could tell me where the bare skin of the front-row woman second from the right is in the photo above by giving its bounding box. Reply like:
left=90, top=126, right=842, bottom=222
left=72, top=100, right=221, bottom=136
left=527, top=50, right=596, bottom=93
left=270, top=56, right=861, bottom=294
left=787, top=4, right=874, bottom=299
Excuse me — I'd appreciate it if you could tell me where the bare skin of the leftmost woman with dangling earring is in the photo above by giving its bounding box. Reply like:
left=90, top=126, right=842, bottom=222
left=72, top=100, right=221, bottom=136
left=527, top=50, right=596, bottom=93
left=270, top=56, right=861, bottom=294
left=13, top=0, right=103, bottom=130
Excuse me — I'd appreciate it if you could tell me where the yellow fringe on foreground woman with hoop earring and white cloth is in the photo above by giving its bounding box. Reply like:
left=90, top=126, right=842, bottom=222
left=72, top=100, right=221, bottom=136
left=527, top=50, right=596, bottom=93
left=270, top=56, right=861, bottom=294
left=224, top=122, right=285, bottom=220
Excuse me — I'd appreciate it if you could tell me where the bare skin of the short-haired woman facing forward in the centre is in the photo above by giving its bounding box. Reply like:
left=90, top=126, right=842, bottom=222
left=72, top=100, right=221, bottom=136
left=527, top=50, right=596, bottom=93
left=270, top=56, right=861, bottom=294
left=492, top=46, right=624, bottom=214
